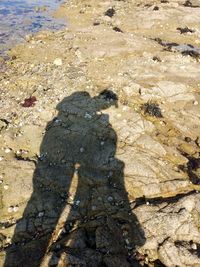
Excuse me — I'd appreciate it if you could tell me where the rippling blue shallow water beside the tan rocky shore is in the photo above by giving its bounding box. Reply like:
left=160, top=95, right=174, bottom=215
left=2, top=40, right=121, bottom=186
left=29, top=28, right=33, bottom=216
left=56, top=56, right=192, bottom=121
left=0, top=0, right=66, bottom=55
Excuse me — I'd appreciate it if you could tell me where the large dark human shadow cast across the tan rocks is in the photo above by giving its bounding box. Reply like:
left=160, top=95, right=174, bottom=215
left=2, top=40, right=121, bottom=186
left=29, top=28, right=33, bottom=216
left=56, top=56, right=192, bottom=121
left=4, top=90, right=145, bottom=267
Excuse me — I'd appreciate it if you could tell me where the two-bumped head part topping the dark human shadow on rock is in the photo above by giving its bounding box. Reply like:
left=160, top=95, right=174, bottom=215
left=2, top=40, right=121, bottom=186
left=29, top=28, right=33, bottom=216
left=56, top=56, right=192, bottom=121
left=56, top=89, right=118, bottom=113
